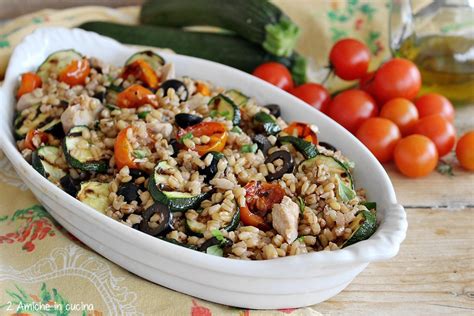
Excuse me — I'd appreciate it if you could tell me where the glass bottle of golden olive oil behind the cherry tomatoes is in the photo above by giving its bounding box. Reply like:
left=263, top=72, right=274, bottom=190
left=397, top=35, right=474, bottom=105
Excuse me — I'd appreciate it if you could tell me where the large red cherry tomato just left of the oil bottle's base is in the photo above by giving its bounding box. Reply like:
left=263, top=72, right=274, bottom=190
left=374, top=58, right=421, bottom=104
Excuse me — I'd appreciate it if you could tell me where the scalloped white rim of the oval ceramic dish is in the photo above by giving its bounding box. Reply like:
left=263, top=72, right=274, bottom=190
left=0, top=27, right=407, bottom=279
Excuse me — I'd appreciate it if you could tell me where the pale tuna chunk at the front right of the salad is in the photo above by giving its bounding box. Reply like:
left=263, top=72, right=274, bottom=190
left=272, top=196, right=300, bottom=244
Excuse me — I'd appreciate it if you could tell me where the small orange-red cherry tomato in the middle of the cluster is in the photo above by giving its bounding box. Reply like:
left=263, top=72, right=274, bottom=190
left=380, top=98, right=418, bottom=136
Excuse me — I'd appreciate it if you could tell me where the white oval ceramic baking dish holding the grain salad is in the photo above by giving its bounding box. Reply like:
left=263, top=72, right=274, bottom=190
left=0, top=28, right=407, bottom=309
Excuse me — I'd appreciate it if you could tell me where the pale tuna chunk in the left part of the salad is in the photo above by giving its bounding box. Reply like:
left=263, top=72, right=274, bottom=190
left=61, top=95, right=103, bottom=133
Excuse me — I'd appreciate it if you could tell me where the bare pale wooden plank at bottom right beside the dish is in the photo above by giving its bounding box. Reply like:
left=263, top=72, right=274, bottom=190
left=313, top=208, right=474, bottom=315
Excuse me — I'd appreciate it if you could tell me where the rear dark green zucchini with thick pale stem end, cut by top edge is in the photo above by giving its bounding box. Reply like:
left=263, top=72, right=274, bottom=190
left=140, top=0, right=299, bottom=57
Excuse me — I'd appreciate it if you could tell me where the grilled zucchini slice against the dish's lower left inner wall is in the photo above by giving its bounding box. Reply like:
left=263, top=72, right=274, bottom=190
left=31, top=146, right=66, bottom=184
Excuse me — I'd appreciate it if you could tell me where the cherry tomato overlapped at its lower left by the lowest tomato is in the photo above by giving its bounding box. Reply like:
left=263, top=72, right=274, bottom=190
left=413, top=114, right=456, bottom=157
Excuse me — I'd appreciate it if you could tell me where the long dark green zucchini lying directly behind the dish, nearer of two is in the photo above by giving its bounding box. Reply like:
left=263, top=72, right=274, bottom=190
left=79, top=22, right=306, bottom=84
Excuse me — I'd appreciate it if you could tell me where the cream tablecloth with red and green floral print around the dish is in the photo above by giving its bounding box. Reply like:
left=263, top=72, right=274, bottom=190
left=0, top=0, right=390, bottom=316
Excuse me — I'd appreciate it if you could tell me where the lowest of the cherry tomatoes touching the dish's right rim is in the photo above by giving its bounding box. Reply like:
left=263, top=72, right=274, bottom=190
left=356, top=117, right=401, bottom=162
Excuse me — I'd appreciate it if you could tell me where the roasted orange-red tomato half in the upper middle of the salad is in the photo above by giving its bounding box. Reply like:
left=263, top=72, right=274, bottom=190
left=177, top=122, right=228, bottom=156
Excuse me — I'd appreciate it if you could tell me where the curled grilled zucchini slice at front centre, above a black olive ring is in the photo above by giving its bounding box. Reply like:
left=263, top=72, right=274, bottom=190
left=148, top=161, right=211, bottom=212
